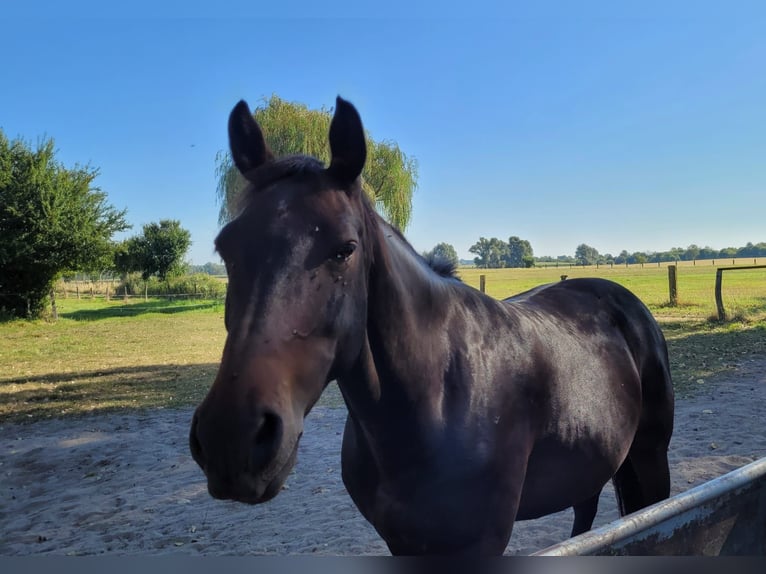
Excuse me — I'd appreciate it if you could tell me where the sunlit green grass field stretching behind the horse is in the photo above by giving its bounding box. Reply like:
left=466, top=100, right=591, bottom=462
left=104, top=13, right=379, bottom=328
left=0, top=265, right=766, bottom=421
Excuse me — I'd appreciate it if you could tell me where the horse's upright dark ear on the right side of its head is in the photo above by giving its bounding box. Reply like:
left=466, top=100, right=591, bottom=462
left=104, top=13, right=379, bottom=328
left=327, top=96, right=367, bottom=189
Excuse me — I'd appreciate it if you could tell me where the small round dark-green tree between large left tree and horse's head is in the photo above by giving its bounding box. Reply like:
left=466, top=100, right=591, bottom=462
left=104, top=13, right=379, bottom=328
left=132, top=219, right=191, bottom=281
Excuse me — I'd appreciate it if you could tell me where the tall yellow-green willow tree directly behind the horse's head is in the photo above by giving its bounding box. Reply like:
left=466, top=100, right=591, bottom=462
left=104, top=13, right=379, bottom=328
left=216, top=95, right=417, bottom=229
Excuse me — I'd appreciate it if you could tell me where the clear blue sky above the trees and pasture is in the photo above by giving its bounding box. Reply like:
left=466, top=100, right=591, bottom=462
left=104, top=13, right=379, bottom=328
left=0, top=1, right=766, bottom=264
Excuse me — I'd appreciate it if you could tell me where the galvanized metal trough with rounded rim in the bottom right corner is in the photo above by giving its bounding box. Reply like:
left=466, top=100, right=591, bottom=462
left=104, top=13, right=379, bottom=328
left=535, top=458, right=766, bottom=556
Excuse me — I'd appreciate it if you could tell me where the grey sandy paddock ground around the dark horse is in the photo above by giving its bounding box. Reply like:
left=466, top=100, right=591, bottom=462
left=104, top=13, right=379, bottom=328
left=0, top=359, right=766, bottom=555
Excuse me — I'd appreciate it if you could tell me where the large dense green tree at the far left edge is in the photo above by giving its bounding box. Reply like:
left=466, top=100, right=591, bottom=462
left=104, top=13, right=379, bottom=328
left=0, top=130, right=130, bottom=317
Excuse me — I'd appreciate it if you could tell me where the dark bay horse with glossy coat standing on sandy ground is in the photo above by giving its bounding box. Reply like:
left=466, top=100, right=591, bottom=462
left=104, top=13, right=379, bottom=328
left=190, top=98, right=673, bottom=554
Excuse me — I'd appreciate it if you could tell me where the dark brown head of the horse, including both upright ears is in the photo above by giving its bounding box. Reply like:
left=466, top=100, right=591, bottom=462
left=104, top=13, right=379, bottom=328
left=189, top=98, right=370, bottom=503
